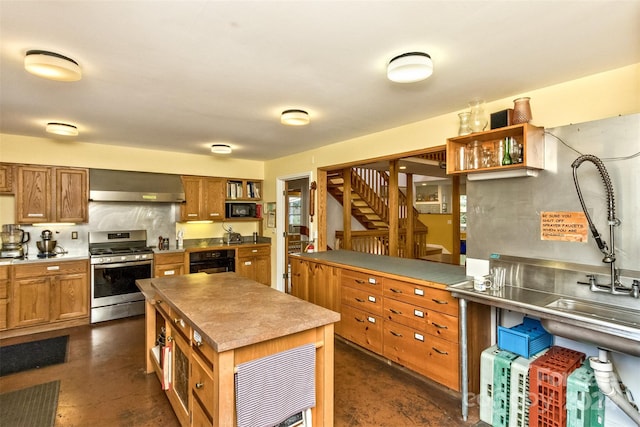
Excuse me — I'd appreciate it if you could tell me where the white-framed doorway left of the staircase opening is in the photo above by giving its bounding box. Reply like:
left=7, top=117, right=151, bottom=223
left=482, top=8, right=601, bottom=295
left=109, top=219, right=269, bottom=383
left=276, top=173, right=311, bottom=293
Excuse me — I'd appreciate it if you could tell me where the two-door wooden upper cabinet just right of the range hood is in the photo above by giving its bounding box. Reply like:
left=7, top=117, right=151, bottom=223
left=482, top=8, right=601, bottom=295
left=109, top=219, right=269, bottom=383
left=180, top=176, right=225, bottom=221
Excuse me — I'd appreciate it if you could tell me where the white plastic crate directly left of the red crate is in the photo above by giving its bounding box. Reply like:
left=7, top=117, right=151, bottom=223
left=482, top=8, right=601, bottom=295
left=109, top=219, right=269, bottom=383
left=509, top=349, right=547, bottom=427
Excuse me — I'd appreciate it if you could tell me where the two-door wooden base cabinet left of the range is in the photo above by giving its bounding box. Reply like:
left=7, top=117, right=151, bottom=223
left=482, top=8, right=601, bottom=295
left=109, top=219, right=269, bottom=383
left=8, top=261, right=89, bottom=328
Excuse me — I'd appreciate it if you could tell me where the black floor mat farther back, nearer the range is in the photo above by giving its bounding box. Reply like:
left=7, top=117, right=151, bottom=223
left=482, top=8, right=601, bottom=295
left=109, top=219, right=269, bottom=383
left=0, top=335, right=69, bottom=376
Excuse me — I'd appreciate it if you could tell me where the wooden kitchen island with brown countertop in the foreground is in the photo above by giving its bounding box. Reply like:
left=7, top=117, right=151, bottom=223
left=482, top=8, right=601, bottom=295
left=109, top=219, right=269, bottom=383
left=137, top=273, right=340, bottom=426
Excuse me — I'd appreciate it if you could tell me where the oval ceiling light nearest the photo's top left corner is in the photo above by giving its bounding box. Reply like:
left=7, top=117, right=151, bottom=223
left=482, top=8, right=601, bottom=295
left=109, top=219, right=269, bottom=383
left=24, top=50, right=82, bottom=82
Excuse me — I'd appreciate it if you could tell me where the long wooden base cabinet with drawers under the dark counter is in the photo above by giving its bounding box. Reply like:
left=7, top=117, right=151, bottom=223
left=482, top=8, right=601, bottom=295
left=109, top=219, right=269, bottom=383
left=291, top=257, right=490, bottom=392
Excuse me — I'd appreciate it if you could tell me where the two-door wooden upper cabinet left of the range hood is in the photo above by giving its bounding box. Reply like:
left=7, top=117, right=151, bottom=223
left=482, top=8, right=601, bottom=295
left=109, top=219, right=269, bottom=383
left=16, top=165, right=89, bottom=224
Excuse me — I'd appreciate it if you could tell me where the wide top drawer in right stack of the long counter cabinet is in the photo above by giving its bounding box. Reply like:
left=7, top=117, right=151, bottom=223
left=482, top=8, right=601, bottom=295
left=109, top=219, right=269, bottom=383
left=384, top=279, right=458, bottom=316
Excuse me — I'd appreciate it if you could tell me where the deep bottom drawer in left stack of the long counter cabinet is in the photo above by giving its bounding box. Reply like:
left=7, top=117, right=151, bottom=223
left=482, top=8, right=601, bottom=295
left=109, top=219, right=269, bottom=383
left=341, top=305, right=382, bottom=354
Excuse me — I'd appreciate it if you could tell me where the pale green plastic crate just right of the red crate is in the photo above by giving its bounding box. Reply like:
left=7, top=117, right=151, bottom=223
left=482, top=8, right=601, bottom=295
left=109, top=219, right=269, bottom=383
left=567, top=362, right=604, bottom=427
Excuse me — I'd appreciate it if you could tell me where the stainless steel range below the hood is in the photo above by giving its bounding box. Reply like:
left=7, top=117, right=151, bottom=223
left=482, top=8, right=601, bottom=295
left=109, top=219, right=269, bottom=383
left=89, top=230, right=153, bottom=323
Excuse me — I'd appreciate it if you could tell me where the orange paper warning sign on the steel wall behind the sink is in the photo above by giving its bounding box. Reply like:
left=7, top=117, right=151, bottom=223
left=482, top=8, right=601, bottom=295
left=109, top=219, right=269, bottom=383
left=540, top=212, right=589, bottom=242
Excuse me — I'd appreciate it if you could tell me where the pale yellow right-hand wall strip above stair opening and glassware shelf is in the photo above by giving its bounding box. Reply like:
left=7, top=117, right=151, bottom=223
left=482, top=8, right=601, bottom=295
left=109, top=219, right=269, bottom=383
left=264, top=64, right=640, bottom=237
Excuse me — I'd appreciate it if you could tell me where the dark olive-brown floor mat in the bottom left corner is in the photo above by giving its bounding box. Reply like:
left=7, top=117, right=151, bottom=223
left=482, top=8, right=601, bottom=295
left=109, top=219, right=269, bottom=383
left=0, top=381, right=60, bottom=427
